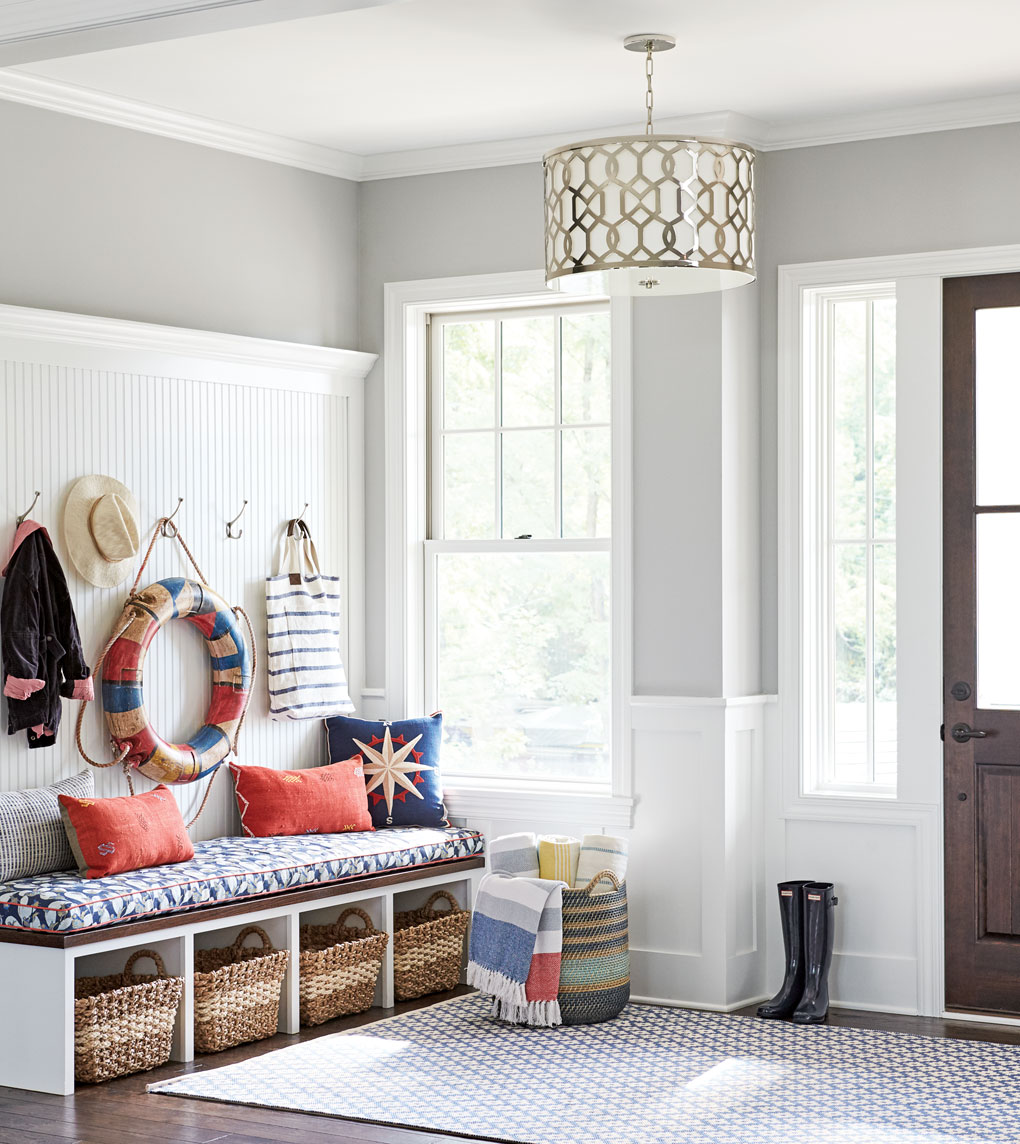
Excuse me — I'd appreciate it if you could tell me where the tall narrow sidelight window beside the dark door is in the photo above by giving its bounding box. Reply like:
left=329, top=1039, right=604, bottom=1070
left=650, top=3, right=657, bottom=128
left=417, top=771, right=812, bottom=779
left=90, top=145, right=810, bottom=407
left=800, top=284, right=897, bottom=795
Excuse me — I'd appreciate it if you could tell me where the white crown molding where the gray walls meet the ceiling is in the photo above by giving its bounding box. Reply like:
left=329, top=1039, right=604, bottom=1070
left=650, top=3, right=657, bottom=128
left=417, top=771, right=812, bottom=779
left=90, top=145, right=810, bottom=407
left=0, top=69, right=1020, bottom=182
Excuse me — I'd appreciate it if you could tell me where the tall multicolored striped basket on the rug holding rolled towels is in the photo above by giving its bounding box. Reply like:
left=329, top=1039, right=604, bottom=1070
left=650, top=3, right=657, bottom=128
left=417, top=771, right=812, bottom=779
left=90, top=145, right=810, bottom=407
left=557, top=869, right=630, bottom=1025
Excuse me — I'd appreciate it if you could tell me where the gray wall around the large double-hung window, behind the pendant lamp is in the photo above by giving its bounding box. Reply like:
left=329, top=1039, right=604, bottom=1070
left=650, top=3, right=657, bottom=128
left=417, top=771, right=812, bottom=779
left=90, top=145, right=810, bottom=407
left=359, top=162, right=759, bottom=696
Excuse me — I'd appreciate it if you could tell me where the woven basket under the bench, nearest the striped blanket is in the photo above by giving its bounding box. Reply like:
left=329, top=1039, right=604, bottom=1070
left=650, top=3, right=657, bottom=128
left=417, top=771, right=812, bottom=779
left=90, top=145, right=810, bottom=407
left=393, top=890, right=471, bottom=1001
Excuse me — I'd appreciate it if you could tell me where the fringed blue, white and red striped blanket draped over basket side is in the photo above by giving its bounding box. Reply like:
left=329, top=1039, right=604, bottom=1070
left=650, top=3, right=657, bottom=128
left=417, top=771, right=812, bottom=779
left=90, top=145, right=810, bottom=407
left=468, top=874, right=563, bottom=1025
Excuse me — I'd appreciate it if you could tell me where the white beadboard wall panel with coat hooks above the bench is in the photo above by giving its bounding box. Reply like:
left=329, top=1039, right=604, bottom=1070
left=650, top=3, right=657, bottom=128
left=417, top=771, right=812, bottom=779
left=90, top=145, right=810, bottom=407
left=0, top=307, right=374, bottom=840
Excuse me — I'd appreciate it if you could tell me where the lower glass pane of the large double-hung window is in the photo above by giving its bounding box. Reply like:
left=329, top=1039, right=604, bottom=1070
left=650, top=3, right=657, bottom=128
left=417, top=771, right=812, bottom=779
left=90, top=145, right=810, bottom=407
left=436, top=553, right=609, bottom=782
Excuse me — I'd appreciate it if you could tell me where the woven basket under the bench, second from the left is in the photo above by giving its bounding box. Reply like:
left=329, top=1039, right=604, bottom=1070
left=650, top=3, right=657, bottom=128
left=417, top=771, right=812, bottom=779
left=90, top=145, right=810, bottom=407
left=194, top=925, right=288, bottom=1052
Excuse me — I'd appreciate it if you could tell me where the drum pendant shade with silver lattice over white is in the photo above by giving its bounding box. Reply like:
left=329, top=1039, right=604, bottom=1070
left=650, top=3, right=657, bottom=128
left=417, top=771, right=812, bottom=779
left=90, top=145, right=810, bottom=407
left=544, top=135, right=755, bottom=295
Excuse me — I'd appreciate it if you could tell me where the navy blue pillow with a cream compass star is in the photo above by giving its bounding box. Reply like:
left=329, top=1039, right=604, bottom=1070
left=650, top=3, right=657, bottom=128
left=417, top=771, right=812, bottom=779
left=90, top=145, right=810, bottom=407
left=326, top=712, right=449, bottom=828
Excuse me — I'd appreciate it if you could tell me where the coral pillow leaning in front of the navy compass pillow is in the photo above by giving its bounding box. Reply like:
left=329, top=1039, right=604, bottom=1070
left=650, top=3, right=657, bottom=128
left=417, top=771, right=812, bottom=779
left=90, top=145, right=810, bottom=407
left=230, top=756, right=375, bottom=839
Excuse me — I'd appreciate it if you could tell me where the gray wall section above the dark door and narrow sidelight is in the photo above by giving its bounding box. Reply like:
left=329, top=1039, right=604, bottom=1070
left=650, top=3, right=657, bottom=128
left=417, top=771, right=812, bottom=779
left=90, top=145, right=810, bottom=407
left=758, top=124, right=1020, bottom=691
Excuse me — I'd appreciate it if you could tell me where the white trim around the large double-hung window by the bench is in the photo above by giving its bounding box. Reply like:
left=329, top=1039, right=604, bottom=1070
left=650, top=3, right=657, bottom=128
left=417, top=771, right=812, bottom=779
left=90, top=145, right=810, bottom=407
left=383, top=271, right=633, bottom=826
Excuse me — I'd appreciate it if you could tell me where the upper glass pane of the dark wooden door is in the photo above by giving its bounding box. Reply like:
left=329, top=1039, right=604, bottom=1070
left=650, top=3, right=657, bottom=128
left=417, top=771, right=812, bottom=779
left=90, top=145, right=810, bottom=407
left=974, top=307, right=1020, bottom=505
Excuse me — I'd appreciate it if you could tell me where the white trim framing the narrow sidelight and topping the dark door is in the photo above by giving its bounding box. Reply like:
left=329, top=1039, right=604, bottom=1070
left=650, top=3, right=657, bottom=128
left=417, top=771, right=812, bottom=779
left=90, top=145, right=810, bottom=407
left=776, top=245, right=1020, bottom=823
